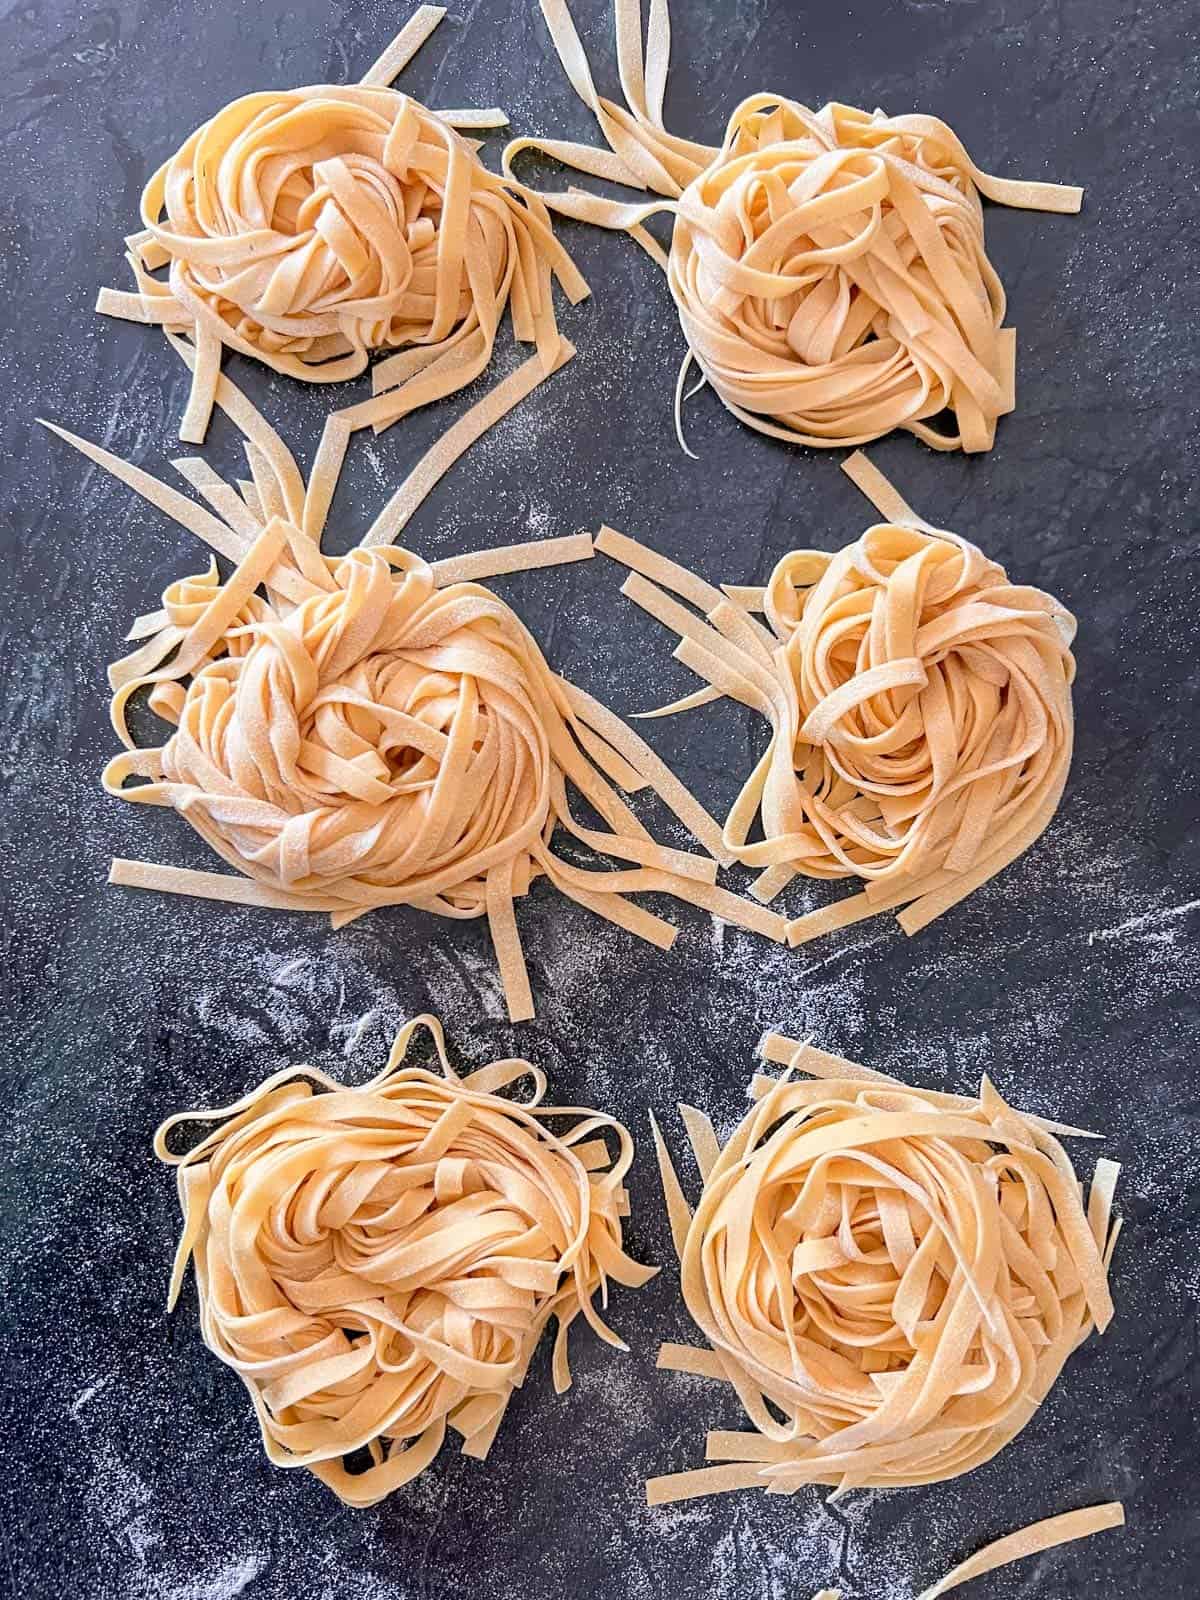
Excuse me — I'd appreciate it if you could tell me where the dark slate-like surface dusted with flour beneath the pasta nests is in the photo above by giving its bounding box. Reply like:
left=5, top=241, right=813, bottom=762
left=0, top=0, right=1200, bottom=1600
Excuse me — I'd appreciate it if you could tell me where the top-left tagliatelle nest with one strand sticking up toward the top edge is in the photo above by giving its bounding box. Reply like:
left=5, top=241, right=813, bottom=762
left=96, top=6, right=587, bottom=467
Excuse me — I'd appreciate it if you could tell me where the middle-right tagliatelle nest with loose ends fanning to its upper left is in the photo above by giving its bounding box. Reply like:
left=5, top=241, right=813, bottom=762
left=597, top=454, right=1075, bottom=944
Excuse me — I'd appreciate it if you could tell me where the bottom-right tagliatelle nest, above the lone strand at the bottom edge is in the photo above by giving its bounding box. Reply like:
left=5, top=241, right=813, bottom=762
left=646, top=1034, right=1120, bottom=1504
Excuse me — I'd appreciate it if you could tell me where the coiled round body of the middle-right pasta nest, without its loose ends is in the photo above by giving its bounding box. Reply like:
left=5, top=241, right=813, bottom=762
left=752, top=523, right=1075, bottom=893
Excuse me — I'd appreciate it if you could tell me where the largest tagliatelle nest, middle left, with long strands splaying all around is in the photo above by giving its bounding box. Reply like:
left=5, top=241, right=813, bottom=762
left=42, top=363, right=786, bottom=1021
